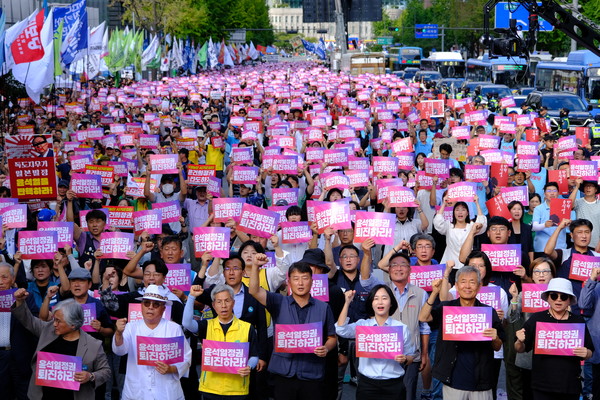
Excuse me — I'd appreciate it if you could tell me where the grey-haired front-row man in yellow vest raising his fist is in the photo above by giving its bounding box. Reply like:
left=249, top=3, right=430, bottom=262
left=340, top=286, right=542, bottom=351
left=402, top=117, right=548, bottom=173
left=183, top=285, right=258, bottom=400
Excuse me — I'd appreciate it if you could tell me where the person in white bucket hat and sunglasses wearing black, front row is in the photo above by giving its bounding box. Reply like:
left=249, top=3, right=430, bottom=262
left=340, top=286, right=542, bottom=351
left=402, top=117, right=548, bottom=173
left=515, top=278, right=594, bottom=400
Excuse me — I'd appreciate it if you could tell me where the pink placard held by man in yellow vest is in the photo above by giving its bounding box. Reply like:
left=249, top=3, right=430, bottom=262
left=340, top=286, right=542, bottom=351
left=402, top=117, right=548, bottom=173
left=202, top=339, right=250, bottom=374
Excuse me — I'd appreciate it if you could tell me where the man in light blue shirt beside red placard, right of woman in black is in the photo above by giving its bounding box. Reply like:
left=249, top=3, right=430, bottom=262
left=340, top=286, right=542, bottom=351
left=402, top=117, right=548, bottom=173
left=531, top=182, right=567, bottom=252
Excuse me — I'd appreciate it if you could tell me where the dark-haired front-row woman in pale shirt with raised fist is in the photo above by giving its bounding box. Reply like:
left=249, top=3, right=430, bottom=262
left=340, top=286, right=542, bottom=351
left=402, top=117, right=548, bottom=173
left=335, top=285, right=415, bottom=400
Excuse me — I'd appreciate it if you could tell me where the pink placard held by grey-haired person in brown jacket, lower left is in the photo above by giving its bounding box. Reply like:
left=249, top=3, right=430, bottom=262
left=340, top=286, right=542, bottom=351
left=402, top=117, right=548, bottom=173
left=35, top=351, right=82, bottom=390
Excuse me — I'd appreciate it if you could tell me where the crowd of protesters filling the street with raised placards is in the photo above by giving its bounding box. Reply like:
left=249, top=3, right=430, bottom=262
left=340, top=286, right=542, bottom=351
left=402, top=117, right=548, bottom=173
left=0, top=63, right=600, bottom=400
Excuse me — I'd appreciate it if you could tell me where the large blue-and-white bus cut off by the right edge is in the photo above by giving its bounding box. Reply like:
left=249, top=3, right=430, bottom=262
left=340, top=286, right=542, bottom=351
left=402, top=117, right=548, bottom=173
left=535, top=50, right=600, bottom=116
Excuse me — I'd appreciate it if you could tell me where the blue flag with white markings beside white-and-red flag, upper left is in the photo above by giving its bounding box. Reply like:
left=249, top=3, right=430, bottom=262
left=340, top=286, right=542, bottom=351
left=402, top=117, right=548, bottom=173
left=54, top=0, right=88, bottom=66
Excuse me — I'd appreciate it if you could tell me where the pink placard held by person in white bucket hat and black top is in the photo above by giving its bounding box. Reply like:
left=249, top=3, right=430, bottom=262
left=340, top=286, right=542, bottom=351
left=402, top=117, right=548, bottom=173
left=533, top=322, right=585, bottom=356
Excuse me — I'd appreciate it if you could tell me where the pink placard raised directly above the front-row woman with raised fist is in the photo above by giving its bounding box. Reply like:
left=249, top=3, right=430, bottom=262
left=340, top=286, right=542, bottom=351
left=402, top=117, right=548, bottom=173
left=354, top=211, right=396, bottom=246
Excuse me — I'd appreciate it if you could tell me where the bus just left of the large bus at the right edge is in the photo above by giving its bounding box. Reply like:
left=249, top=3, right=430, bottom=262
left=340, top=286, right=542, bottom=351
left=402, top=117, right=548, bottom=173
left=466, top=53, right=529, bottom=87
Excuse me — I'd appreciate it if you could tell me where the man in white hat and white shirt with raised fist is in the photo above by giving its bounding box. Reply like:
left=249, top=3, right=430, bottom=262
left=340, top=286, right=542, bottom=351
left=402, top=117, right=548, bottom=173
left=112, top=285, right=192, bottom=400
